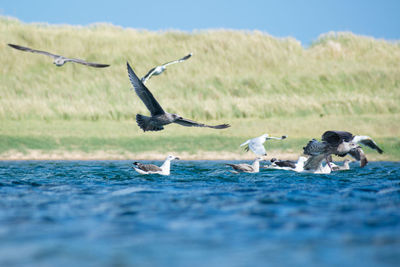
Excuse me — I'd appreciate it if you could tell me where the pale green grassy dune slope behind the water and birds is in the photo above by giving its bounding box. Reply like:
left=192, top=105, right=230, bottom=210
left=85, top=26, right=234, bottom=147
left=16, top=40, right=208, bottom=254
left=0, top=17, right=400, bottom=160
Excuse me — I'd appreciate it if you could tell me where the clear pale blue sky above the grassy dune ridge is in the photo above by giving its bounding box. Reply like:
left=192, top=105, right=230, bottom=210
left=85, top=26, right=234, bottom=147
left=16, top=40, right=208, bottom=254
left=0, top=0, right=400, bottom=45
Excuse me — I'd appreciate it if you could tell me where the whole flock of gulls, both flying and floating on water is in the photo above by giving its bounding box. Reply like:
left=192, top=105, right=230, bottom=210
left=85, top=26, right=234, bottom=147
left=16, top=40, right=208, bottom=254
left=8, top=44, right=383, bottom=175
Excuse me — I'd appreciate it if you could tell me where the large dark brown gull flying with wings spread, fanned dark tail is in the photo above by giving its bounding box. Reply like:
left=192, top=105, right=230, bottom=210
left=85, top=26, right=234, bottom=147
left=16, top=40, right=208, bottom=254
left=126, top=62, right=230, bottom=132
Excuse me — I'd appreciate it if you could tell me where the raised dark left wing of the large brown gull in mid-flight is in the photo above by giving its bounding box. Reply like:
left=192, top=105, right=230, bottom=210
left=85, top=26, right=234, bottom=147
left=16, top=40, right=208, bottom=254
left=126, top=62, right=165, bottom=116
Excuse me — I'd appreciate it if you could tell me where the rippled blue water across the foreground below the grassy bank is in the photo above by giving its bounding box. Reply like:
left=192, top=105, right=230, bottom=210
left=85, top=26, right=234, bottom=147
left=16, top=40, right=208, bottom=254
left=0, top=161, right=400, bottom=266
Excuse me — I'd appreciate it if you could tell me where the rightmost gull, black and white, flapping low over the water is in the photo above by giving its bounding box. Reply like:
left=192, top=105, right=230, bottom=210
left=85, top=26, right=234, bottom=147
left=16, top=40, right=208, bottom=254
left=322, top=131, right=383, bottom=167
